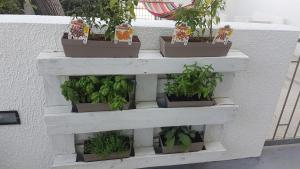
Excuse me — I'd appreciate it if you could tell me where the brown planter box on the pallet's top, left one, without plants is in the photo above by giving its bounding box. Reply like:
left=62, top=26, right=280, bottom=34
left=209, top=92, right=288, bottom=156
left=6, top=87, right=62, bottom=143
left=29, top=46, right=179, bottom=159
left=61, top=35, right=141, bottom=58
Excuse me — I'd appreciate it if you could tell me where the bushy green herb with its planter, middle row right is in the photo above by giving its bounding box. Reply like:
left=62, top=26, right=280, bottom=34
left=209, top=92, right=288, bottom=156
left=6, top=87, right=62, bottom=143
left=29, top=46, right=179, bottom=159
left=164, top=63, right=222, bottom=108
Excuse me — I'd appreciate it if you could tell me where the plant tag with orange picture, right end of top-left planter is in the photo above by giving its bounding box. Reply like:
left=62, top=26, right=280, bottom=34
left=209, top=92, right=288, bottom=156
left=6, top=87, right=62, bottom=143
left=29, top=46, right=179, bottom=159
left=114, top=23, right=134, bottom=45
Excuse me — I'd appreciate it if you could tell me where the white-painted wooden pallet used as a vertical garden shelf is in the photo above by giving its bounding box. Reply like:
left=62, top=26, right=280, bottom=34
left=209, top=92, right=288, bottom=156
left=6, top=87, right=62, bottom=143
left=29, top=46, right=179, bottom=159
left=37, top=50, right=249, bottom=169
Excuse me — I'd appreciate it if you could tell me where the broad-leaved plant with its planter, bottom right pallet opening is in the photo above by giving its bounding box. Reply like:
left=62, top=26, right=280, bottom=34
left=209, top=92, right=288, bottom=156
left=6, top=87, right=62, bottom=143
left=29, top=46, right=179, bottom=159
left=159, top=126, right=204, bottom=154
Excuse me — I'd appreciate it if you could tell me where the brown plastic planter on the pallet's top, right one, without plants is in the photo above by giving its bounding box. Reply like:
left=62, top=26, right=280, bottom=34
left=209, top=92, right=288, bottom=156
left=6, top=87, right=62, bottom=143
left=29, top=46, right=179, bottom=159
left=160, top=36, right=232, bottom=57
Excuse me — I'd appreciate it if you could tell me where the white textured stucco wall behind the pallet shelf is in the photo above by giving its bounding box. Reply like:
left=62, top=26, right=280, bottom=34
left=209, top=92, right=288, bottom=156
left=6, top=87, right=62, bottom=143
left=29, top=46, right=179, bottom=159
left=0, top=16, right=298, bottom=169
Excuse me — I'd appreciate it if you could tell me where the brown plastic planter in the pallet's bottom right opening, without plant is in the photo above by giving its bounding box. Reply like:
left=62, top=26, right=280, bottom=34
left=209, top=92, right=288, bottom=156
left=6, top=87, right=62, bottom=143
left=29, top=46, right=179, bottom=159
left=159, top=137, right=204, bottom=154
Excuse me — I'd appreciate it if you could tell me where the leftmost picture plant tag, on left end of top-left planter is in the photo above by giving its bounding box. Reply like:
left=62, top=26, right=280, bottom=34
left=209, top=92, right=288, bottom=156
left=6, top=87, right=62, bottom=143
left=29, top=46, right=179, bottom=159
left=68, top=19, right=90, bottom=44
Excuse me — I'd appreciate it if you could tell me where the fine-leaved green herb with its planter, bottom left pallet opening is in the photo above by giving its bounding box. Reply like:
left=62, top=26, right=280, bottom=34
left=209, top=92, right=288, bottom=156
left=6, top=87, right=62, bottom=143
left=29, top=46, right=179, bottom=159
left=80, top=131, right=132, bottom=162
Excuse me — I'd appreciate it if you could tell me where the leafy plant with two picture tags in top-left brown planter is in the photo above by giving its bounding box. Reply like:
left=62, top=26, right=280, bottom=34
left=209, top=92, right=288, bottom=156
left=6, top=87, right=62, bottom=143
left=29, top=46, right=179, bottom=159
left=61, top=0, right=141, bottom=58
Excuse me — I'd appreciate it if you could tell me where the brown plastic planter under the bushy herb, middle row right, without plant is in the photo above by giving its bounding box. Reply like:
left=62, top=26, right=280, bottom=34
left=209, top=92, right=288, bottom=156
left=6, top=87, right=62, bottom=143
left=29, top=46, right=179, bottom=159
left=164, top=94, right=216, bottom=108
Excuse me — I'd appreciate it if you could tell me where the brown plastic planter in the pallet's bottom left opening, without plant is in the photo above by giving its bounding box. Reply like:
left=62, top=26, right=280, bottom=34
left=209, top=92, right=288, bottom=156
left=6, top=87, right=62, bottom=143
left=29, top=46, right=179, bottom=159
left=82, top=143, right=132, bottom=162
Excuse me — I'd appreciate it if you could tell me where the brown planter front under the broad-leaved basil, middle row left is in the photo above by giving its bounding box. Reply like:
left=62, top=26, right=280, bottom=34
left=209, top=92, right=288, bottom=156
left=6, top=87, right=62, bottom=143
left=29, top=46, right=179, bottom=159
left=75, top=103, right=130, bottom=113
